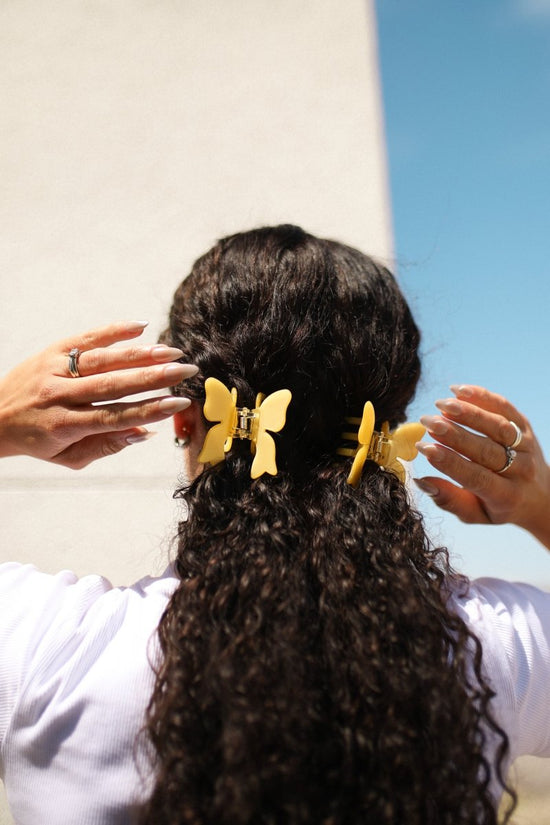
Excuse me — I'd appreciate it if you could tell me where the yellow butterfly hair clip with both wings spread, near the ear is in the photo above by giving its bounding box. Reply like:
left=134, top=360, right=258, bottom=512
left=199, top=378, right=292, bottom=478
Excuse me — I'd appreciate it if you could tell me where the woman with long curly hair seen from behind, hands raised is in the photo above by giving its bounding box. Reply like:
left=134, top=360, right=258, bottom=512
left=0, top=226, right=550, bottom=825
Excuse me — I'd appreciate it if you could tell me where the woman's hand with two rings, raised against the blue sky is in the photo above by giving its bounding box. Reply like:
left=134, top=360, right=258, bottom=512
left=417, top=385, right=550, bottom=549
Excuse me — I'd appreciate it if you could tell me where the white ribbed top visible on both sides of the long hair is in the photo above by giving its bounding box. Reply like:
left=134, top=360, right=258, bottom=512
left=0, top=563, right=550, bottom=825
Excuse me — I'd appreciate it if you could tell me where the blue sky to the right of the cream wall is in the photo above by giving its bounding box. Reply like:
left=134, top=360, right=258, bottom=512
left=376, top=0, right=550, bottom=586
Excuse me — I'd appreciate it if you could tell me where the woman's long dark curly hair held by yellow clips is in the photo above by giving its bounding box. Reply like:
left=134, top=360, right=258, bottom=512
left=140, top=226, right=515, bottom=825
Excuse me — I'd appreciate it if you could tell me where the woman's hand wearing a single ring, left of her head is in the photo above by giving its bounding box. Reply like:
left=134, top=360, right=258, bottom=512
left=0, top=322, right=198, bottom=469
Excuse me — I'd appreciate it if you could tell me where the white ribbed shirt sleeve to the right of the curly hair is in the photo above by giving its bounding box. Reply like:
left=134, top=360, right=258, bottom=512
left=456, top=579, right=550, bottom=759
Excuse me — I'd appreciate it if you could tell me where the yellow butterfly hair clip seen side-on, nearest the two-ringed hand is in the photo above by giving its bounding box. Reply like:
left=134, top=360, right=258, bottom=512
left=336, top=401, right=426, bottom=487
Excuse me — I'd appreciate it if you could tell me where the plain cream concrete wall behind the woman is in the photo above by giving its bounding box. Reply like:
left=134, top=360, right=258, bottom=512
left=0, top=0, right=391, bottom=823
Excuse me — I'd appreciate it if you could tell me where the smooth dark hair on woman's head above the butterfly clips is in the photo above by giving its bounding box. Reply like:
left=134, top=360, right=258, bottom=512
left=164, top=226, right=420, bottom=480
